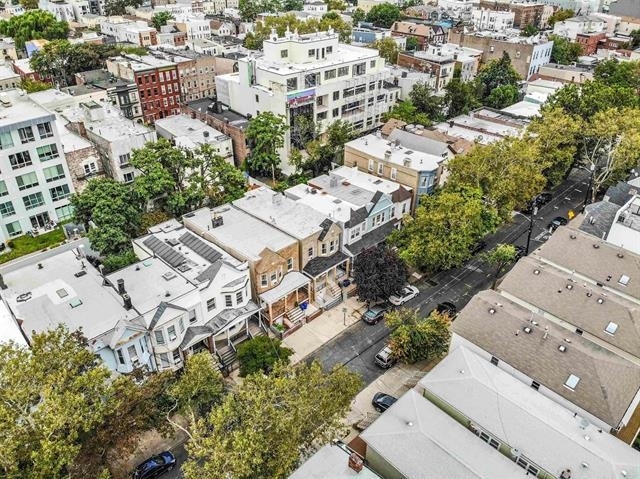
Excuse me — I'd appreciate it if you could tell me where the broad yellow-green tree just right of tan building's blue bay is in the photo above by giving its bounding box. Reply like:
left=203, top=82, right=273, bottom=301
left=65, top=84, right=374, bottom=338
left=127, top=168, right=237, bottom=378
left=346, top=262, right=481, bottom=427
left=447, top=138, right=550, bottom=220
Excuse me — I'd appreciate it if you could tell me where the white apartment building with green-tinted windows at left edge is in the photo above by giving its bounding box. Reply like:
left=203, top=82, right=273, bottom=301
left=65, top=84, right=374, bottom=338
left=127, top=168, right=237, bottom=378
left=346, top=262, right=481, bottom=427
left=0, top=90, right=74, bottom=242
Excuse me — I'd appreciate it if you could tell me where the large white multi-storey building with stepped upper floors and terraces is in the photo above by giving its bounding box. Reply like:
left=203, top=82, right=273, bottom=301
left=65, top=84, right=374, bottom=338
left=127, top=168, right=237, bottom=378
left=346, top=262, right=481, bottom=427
left=216, top=30, right=399, bottom=169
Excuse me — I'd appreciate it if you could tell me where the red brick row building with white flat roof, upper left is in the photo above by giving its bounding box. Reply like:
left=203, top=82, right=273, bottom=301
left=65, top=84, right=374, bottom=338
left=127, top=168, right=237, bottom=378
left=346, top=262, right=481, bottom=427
left=107, top=55, right=181, bottom=123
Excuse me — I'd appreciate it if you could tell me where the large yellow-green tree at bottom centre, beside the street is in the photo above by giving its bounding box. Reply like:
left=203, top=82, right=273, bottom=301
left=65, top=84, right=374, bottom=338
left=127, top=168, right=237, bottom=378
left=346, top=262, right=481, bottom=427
left=183, top=363, right=362, bottom=479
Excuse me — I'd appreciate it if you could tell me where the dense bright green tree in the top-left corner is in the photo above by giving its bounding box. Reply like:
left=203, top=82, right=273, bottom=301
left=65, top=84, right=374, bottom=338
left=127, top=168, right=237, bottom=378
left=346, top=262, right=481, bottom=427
left=0, top=10, right=69, bottom=49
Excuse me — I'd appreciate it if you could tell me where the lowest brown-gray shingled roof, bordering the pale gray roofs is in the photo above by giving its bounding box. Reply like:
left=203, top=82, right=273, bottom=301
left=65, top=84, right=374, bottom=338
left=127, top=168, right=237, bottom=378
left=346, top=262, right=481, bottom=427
left=452, top=290, right=640, bottom=427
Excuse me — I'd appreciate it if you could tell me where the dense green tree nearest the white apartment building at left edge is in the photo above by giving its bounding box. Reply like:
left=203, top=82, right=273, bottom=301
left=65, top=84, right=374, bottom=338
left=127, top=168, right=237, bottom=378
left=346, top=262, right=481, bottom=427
left=70, top=178, right=143, bottom=256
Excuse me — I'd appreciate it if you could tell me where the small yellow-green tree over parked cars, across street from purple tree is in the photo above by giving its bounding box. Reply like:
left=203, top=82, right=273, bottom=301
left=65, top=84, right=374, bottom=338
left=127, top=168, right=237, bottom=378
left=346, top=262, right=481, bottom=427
left=385, top=308, right=451, bottom=364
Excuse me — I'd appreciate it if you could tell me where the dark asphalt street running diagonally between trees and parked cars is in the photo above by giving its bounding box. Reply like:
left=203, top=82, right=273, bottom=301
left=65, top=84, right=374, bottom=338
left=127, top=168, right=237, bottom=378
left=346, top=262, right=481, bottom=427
left=309, top=170, right=588, bottom=385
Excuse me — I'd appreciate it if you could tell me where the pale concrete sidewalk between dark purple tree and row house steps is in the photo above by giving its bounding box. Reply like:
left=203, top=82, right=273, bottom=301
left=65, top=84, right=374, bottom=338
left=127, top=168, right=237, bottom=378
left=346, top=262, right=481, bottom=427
left=283, top=297, right=366, bottom=363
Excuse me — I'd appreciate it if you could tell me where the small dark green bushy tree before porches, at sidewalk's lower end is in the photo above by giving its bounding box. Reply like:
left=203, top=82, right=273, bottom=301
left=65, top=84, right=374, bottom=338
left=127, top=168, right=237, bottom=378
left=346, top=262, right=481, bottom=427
left=238, top=336, right=293, bottom=377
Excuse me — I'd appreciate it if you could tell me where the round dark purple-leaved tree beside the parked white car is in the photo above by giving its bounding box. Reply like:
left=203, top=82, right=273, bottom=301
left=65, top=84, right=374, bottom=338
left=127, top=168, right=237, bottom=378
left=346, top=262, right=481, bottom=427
left=353, top=244, right=409, bottom=304
